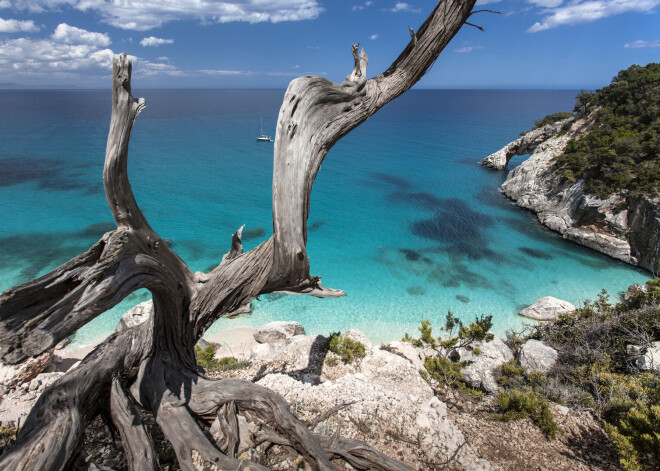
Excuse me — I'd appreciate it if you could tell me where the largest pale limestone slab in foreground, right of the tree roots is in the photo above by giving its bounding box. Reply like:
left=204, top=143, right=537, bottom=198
left=257, top=349, right=492, bottom=470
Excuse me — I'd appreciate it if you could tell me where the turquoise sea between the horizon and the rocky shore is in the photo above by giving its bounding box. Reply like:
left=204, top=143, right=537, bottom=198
left=0, top=90, right=650, bottom=345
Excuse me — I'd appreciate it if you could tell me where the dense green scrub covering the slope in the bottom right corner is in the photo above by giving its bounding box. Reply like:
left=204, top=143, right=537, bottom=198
left=528, top=278, right=660, bottom=471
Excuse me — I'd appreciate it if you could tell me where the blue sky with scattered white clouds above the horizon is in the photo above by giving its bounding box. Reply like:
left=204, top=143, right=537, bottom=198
left=0, top=0, right=660, bottom=89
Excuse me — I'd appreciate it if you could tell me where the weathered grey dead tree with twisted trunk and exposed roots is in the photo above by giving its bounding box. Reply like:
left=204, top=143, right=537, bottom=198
left=0, top=0, right=475, bottom=471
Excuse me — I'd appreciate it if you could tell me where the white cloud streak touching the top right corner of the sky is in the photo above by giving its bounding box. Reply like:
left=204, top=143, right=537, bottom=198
left=527, top=0, right=660, bottom=33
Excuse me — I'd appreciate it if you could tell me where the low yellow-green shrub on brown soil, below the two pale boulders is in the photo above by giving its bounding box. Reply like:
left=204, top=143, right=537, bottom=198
left=493, top=389, right=559, bottom=439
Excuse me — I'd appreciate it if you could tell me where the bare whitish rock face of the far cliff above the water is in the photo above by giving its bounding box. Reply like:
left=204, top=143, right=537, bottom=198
left=492, top=120, right=660, bottom=273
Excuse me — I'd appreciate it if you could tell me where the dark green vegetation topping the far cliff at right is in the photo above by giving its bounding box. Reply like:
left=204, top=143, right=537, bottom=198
left=556, top=63, right=660, bottom=199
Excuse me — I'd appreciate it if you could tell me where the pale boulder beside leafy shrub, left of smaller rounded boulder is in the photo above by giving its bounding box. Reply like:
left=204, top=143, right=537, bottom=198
left=459, top=337, right=513, bottom=394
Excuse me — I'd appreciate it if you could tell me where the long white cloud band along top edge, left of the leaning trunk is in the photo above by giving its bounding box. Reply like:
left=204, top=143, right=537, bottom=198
left=2, top=0, right=324, bottom=31
